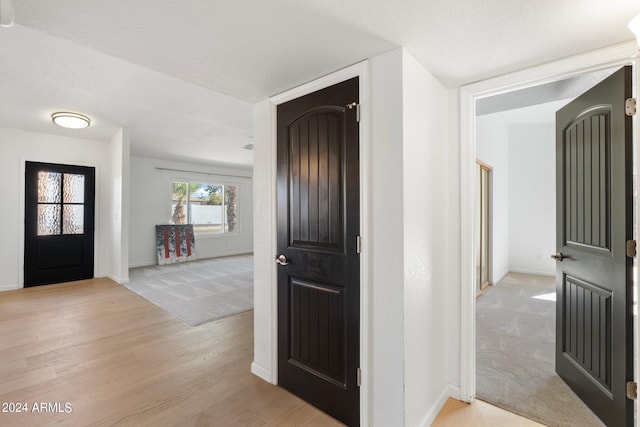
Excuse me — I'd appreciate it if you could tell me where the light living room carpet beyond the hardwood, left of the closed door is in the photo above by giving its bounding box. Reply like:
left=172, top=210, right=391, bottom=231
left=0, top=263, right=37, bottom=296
left=125, top=255, right=253, bottom=326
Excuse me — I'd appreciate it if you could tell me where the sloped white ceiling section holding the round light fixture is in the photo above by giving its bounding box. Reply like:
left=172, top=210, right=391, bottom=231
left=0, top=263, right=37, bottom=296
left=0, top=25, right=253, bottom=166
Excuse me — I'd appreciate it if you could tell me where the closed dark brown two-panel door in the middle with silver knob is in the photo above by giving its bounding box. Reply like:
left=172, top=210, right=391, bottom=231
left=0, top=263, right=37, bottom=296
left=277, top=78, right=360, bottom=426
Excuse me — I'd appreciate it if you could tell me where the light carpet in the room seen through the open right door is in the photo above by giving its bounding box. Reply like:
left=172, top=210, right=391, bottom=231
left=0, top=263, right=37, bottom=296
left=476, top=273, right=604, bottom=427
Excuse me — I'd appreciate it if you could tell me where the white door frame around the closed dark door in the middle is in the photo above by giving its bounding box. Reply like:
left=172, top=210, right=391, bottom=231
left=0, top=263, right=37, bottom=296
left=252, top=61, right=370, bottom=426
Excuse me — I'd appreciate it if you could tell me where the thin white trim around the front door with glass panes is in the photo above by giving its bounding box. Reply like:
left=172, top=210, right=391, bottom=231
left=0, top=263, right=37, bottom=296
left=16, top=157, right=100, bottom=291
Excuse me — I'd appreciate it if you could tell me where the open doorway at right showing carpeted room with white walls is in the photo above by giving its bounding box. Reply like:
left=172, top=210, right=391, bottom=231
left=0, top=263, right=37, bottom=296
left=474, top=70, right=610, bottom=426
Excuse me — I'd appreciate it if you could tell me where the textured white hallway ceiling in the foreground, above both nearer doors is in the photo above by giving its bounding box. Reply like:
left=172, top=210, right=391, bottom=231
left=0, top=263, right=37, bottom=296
left=16, top=0, right=640, bottom=102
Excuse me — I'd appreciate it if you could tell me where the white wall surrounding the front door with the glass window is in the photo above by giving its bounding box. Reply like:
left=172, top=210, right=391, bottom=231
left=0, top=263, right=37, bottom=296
left=0, top=128, right=112, bottom=290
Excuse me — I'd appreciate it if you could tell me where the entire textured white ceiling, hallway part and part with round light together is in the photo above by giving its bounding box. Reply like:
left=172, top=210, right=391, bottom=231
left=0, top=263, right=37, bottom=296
left=0, top=0, right=640, bottom=165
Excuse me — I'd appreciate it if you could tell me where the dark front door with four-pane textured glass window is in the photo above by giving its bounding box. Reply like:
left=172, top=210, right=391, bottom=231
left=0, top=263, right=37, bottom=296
left=24, top=162, right=95, bottom=287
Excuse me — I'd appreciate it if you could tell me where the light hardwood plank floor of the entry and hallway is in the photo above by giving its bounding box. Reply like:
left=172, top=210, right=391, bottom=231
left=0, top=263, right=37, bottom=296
left=0, top=279, right=538, bottom=427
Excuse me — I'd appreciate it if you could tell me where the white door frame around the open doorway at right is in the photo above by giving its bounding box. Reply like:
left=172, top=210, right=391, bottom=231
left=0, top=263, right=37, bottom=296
left=460, top=41, right=640, bottom=412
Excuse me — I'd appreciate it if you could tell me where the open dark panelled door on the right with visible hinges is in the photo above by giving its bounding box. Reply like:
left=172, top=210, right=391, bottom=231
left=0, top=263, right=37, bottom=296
left=555, top=67, right=633, bottom=426
